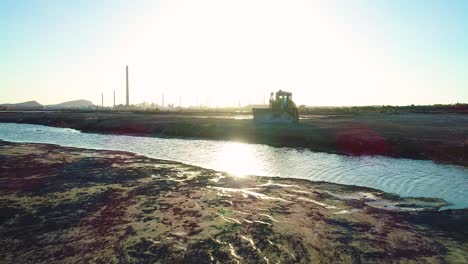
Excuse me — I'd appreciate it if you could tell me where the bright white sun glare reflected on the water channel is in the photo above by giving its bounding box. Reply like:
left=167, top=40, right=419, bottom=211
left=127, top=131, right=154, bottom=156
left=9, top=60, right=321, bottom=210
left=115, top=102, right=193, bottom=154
left=214, top=142, right=262, bottom=177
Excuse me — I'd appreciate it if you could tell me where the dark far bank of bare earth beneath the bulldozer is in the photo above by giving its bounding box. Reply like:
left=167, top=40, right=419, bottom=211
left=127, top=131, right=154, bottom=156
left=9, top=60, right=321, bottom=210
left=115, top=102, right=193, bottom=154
left=0, top=112, right=468, bottom=166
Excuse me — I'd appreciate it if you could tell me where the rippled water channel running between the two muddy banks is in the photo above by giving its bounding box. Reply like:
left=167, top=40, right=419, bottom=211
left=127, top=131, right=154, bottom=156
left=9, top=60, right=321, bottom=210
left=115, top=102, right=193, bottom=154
left=0, top=123, right=468, bottom=208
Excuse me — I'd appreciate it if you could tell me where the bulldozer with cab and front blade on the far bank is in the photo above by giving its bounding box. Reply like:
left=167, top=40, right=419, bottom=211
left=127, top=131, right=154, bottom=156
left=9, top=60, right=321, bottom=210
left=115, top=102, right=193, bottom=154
left=252, top=90, right=299, bottom=123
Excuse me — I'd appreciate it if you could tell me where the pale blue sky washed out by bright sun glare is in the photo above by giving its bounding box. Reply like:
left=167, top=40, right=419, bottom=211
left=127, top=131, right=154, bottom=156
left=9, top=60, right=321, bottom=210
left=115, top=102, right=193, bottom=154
left=0, top=0, right=468, bottom=106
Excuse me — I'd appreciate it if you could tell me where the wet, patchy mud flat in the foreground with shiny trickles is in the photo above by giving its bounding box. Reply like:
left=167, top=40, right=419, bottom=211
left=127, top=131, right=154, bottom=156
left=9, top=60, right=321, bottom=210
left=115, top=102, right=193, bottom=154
left=0, top=142, right=468, bottom=263
